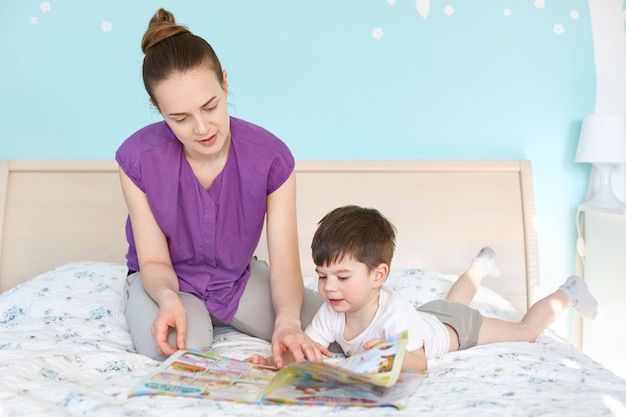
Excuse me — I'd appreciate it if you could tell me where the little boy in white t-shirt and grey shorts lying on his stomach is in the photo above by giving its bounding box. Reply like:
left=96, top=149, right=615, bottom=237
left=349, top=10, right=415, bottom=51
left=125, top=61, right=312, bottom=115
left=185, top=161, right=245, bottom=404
left=249, top=206, right=598, bottom=372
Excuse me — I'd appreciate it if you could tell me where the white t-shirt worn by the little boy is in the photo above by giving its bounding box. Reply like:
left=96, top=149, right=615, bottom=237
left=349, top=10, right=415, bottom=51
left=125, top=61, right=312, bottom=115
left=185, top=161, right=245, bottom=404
left=305, top=286, right=450, bottom=359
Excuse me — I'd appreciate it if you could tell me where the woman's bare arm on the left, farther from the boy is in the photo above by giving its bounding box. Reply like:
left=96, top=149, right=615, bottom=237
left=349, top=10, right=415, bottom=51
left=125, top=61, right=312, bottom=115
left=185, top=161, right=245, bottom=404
left=120, top=169, right=187, bottom=356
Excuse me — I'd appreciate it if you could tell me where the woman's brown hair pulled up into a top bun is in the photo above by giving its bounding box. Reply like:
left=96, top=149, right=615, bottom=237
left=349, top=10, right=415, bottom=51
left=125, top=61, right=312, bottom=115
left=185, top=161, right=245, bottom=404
left=141, top=8, right=224, bottom=107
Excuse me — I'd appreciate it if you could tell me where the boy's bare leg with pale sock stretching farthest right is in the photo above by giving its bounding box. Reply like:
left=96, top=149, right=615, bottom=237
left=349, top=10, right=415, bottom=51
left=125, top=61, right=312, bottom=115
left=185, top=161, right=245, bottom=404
left=478, top=275, right=599, bottom=345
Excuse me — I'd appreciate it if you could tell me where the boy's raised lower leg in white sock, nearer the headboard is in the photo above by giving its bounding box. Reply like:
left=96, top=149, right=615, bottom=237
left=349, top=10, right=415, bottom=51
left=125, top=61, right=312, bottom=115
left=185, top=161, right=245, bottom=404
left=446, top=247, right=500, bottom=305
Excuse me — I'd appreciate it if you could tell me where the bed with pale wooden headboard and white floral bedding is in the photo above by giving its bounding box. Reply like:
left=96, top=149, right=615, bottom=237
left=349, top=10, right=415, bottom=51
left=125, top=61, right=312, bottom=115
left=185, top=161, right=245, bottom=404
left=0, top=160, right=626, bottom=417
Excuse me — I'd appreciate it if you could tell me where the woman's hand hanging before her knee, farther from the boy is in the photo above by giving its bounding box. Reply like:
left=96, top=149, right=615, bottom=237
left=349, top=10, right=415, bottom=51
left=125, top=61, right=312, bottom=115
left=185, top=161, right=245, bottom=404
left=150, top=292, right=187, bottom=356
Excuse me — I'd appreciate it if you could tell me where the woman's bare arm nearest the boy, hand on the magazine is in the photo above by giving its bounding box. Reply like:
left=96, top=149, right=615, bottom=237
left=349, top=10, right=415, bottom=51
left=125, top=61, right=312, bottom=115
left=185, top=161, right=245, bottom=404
left=267, top=173, right=322, bottom=368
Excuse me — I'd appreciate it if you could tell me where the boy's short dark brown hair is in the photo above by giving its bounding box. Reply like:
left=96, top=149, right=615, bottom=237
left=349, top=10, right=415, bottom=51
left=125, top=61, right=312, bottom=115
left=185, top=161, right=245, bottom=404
left=311, top=206, right=396, bottom=271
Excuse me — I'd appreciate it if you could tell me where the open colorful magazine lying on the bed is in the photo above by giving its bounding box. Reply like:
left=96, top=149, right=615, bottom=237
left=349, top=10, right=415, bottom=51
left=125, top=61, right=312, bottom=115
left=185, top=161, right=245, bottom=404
left=128, top=332, right=424, bottom=409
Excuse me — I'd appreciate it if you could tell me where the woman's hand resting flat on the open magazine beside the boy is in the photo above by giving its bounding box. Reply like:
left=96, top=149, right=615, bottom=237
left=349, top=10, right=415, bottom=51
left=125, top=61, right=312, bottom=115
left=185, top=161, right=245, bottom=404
left=272, top=322, right=331, bottom=369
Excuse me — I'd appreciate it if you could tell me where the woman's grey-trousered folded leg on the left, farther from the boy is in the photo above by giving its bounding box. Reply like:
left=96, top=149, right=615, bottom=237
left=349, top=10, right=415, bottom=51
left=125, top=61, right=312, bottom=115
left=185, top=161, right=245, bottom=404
left=124, top=272, right=213, bottom=361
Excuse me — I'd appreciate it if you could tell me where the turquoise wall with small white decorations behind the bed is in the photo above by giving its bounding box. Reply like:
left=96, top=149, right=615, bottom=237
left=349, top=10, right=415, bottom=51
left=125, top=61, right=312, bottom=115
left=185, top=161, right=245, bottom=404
left=0, top=0, right=595, bottom=324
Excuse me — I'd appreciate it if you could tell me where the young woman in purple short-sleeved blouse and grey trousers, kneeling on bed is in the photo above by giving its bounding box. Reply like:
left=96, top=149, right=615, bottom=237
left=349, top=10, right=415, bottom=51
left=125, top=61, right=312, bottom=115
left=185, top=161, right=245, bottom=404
left=116, top=9, right=322, bottom=366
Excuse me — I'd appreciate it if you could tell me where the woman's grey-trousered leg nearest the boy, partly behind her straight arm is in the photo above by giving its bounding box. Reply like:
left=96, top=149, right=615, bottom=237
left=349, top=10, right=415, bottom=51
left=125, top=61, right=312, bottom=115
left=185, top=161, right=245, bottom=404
left=229, top=259, right=323, bottom=342
